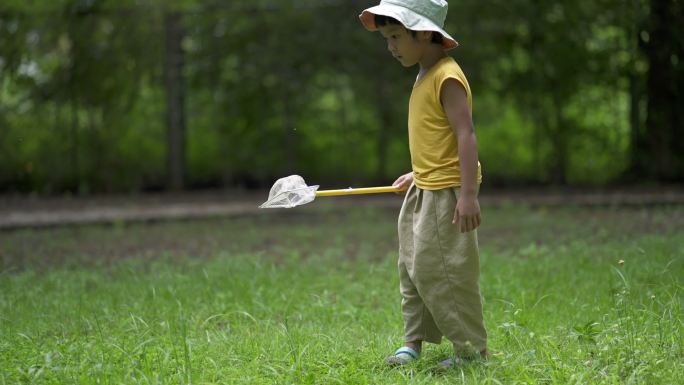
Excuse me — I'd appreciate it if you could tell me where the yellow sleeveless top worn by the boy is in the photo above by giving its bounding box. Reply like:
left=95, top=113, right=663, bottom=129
left=408, top=57, right=482, bottom=190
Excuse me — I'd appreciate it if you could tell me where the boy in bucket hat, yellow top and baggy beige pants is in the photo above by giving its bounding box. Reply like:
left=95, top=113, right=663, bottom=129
left=359, top=0, right=487, bottom=367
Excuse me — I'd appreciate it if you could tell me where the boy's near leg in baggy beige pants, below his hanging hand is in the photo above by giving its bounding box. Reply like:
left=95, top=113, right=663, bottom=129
left=402, top=189, right=487, bottom=356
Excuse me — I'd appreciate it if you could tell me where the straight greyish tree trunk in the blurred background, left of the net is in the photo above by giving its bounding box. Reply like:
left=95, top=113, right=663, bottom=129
left=164, top=12, right=185, bottom=191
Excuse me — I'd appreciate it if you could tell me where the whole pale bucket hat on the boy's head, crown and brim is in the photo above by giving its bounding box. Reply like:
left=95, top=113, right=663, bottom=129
left=359, top=0, right=458, bottom=49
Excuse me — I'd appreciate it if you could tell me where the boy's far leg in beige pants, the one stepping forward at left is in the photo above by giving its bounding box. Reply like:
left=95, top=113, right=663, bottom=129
left=398, top=186, right=442, bottom=344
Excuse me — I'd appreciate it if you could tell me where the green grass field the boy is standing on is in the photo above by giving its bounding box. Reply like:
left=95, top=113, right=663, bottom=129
left=0, top=203, right=684, bottom=384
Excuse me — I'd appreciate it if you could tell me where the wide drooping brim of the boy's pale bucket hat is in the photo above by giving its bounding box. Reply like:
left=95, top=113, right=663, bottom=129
left=359, top=4, right=458, bottom=50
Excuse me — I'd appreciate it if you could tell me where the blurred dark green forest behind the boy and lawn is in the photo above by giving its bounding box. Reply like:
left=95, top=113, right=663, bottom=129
left=0, top=0, right=684, bottom=195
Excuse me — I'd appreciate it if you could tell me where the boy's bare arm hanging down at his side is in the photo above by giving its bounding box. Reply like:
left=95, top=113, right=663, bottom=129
left=440, top=79, right=481, bottom=233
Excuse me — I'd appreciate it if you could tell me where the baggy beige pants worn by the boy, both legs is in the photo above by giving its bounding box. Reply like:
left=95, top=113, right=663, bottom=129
left=399, top=185, right=487, bottom=354
